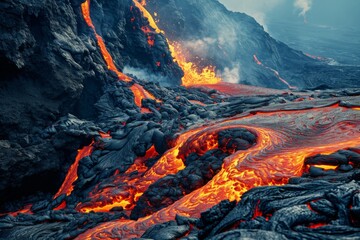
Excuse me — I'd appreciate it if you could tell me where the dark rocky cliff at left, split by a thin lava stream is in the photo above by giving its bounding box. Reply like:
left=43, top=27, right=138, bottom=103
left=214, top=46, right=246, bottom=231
left=0, top=0, right=182, bottom=205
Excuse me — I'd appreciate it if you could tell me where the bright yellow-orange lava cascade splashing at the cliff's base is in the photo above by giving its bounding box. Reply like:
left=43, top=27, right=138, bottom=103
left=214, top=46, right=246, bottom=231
left=133, top=0, right=221, bottom=87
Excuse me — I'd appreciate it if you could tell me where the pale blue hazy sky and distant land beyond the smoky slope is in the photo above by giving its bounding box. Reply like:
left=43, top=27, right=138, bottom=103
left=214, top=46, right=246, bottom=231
left=219, top=0, right=360, bottom=65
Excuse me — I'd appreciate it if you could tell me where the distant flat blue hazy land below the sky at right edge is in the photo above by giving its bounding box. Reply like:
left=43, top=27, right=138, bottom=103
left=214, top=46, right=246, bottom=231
left=267, top=19, right=360, bottom=66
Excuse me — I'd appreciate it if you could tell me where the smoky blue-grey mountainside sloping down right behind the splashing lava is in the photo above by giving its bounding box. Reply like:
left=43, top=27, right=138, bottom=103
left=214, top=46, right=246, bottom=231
left=147, top=0, right=360, bottom=89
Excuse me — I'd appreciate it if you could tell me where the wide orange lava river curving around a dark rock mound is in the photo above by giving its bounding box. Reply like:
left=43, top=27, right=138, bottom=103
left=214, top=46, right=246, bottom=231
left=78, top=104, right=360, bottom=239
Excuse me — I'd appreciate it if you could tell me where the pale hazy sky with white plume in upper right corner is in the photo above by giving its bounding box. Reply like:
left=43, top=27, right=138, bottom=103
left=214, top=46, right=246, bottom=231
left=219, top=0, right=360, bottom=29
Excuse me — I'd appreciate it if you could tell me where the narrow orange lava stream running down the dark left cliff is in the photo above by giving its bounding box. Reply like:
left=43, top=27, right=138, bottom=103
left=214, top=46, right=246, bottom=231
left=81, top=0, right=159, bottom=108
